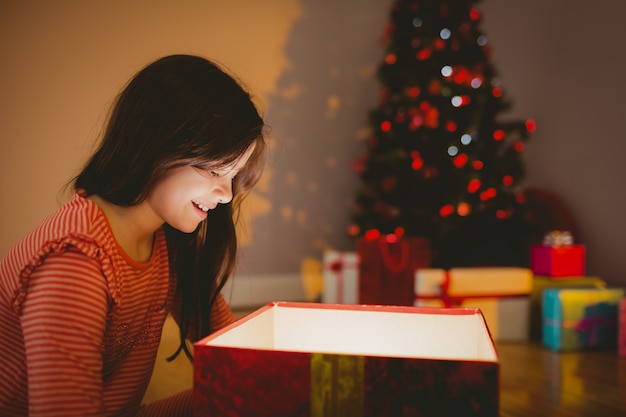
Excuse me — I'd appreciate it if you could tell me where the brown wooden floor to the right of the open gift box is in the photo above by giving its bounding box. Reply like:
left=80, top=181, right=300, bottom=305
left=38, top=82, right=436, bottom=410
left=497, top=344, right=626, bottom=417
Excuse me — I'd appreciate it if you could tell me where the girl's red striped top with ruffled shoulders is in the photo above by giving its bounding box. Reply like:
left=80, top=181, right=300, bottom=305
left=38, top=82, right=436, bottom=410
left=0, top=194, right=234, bottom=417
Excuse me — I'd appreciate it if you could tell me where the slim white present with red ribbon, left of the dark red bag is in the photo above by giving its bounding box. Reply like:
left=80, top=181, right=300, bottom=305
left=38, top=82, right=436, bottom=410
left=322, top=251, right=359, bottom=304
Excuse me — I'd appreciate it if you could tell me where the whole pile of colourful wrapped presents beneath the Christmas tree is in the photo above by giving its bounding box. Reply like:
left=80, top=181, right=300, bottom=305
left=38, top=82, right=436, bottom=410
left=322, top=231, right=626, bottom=357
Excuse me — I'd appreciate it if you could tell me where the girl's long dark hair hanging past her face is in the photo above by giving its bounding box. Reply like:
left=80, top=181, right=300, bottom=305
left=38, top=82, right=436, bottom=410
left=74, top=55, right=266, bottom=357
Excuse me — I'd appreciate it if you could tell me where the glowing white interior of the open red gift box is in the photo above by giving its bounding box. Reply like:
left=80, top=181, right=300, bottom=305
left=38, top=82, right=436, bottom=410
left=200, top=304, right=497, bottom=361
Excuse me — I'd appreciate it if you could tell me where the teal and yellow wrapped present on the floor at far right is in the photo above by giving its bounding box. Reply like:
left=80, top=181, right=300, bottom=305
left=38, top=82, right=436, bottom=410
left=542, top=288, right=624, bottom=351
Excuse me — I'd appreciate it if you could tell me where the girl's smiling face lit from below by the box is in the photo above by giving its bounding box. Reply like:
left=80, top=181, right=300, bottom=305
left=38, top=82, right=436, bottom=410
left=147, top=147, right=254, bottom=233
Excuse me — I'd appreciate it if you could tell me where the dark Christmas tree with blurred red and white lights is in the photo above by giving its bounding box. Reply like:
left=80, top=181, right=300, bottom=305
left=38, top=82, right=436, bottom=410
left=350, top=0, right=535, bottom=268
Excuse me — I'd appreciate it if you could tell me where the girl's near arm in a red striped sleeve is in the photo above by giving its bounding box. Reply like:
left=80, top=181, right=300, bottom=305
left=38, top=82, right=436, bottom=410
left=21, top=250, right=108, bottom=417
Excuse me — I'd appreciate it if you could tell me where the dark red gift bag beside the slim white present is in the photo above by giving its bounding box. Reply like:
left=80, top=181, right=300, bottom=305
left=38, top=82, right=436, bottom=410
left=356, top=235, right=431, bottom=306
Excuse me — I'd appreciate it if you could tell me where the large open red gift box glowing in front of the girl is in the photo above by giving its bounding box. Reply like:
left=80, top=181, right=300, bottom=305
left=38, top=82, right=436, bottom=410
left=193, top=302, right=499, bottom=417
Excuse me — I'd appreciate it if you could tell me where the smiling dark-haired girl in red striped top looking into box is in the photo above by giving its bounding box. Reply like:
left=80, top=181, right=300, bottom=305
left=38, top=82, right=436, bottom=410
left=0, top=55, right=266, bottom=417
